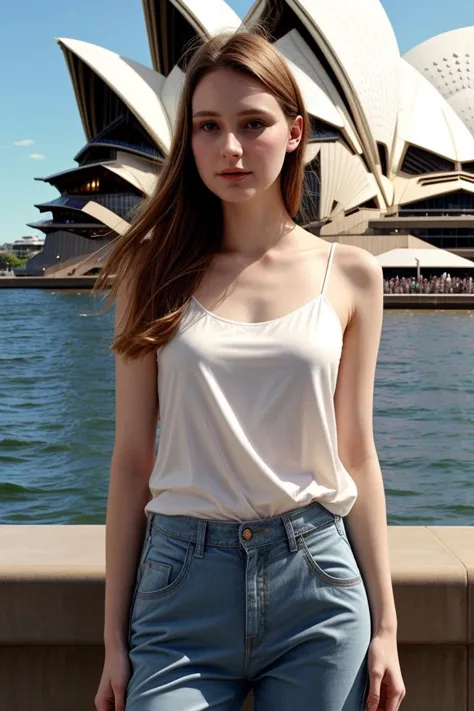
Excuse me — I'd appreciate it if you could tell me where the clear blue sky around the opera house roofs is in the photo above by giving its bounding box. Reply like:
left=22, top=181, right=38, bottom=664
left=0, top=0, right=474, bottom=244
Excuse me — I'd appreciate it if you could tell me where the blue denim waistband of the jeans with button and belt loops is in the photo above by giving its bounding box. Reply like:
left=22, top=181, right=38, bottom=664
left=147, top=501, right=340, bottom=557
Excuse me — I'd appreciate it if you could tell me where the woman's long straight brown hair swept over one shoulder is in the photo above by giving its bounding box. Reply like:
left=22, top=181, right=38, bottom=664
left=92, top=32, right=309, bottom=360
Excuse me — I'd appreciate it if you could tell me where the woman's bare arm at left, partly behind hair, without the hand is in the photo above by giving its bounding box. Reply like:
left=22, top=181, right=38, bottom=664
left=104, top=289, right=159, bottom=652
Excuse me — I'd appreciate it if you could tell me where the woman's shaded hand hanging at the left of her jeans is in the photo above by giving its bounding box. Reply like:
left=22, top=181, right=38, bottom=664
left=94, top=647, right=131, bottom=711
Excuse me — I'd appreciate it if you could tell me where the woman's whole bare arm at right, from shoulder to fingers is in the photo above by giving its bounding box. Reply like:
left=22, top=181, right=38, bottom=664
left=334, top=248, right=405, bottom=711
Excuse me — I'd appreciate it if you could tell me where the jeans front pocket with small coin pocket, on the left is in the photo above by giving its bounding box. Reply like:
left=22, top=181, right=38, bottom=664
left=135, top=527, right=194, bottom=600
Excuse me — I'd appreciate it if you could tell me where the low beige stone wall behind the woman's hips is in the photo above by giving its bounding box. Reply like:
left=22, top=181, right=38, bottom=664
left=0, top=525, right=474, bottom=711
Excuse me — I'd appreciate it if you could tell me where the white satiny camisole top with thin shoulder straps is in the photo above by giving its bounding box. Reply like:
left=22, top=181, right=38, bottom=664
left=145, top=243, right=357, bottom=521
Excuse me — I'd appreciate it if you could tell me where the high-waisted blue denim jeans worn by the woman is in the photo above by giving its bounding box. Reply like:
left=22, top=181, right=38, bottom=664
left=125, top=502, right=371, bottom=711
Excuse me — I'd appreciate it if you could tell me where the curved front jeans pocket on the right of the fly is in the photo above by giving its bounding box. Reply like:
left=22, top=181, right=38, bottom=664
left=298, top=521, right=362, bottom=587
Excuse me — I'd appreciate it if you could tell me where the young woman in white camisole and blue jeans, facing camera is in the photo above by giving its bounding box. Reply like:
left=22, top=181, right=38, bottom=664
left=95, top=33, right=405, bottom=711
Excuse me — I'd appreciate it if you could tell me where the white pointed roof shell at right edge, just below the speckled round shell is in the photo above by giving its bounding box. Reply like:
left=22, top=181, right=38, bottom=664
left=392, top=59, right=474, bottom=172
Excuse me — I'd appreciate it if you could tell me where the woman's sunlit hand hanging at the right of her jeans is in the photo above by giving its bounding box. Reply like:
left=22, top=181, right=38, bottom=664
left=365, top=632, right=406, bottom=711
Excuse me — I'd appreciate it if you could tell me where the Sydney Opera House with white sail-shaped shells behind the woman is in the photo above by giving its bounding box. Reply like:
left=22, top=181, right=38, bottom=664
left=27, top=0, right=474, bottom=276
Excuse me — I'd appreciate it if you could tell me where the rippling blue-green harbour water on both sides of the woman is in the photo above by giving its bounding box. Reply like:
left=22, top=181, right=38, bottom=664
left=0, top=289, right=474, bottom=526
